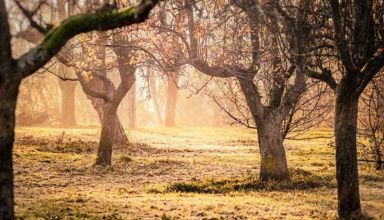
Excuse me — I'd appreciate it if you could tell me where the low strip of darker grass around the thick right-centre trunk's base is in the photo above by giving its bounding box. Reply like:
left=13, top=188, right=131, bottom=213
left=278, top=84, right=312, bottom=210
left=166, top=169, right=335, bottom=193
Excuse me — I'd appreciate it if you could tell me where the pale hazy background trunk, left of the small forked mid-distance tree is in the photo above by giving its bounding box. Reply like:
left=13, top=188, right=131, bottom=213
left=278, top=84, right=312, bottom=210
left=59, top=80, right=76, bottom=128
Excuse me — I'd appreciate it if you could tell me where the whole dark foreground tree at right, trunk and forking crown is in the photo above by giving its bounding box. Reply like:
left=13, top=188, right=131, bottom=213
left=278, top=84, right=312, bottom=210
left=308, top=0, right=384, bottom=219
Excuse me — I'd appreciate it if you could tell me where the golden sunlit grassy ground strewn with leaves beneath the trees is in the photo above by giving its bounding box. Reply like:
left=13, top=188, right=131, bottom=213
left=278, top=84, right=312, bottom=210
left=14, top=127, right=384, bottom=219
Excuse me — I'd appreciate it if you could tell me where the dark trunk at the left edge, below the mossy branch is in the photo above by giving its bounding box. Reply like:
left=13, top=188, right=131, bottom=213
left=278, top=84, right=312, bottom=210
left=0, top=77, right=20, bottom=219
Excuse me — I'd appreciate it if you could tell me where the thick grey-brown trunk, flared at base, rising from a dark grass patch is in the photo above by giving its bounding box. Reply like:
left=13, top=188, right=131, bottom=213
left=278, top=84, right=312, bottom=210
left=257, top=115, right=289, bottom=181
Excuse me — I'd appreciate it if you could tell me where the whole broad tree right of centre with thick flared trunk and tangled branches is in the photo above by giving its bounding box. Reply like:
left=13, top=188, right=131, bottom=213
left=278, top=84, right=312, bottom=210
left=164, top=1, right=310, bottom=181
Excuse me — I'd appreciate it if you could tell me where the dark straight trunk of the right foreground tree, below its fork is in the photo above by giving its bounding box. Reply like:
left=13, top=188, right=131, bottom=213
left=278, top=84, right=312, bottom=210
left=335, top=91, right=361, bottom=219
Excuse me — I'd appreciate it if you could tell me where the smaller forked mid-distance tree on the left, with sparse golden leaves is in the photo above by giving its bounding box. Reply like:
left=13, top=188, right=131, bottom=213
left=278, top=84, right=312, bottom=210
left=68, top=30, right=136, bottom=166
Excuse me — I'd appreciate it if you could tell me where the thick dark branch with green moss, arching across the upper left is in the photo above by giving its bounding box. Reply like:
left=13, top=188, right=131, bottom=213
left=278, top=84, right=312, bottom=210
left=17, top=0, right=159, bottom=78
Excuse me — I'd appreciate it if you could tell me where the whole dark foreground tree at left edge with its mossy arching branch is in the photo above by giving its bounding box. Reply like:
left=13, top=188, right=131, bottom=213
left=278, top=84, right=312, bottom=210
left=0, top=0, right=158, bottom=219
